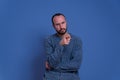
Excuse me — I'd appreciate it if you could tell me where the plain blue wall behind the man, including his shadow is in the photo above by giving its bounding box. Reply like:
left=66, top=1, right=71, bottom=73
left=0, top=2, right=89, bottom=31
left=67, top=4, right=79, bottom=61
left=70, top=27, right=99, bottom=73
left=0, top=0, right=120, bottom=80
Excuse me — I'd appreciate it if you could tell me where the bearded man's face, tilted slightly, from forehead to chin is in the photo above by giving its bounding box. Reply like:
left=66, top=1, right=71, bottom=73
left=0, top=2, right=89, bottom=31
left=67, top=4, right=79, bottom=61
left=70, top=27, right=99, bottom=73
left=53, top=15, right=67, bottom=35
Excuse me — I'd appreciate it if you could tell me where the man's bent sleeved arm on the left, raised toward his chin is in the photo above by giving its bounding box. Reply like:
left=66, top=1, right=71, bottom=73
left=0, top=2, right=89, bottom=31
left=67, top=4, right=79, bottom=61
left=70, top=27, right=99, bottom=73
left=45, top=39, right=63, bottom=68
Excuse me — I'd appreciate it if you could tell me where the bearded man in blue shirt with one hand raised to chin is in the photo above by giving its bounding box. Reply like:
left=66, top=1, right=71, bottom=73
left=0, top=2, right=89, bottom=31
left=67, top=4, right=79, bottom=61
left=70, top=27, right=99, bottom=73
left=44, top=13, right=82, bottom=80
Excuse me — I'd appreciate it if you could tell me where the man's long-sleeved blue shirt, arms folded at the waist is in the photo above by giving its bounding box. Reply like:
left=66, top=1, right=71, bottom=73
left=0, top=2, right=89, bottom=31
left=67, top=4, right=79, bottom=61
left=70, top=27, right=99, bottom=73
left=45, top=34, right=82, bottom=71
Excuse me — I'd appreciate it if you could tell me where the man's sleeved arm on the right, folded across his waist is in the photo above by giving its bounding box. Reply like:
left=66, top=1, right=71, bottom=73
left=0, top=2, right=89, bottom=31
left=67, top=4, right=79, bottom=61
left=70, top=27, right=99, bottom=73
left=60, top=39, right=82, bottom=70
